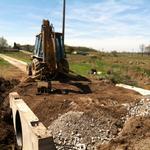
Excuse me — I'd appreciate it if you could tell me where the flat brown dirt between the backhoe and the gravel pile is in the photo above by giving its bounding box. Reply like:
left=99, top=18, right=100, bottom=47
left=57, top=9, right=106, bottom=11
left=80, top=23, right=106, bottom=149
left=14, top=81, right=141, bottom=126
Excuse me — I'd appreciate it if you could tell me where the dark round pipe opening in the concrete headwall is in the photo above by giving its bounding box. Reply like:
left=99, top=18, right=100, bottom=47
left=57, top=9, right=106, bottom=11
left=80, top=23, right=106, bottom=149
left=15, top=111, right=23, bottom=149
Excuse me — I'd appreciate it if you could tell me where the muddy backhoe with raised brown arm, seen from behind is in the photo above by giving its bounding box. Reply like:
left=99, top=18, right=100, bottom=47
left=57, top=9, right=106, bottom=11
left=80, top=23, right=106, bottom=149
left=28, top=20, right=69, bottom=81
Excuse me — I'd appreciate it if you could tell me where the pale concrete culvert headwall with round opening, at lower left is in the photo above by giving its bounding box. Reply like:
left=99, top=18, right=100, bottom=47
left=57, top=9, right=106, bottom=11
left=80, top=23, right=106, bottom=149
left=9, top=92, right=56, bottom=150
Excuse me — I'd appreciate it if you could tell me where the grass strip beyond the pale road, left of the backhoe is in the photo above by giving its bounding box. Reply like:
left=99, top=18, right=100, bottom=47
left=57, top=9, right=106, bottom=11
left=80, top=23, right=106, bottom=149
left=1, top=52, right=31, bottom=63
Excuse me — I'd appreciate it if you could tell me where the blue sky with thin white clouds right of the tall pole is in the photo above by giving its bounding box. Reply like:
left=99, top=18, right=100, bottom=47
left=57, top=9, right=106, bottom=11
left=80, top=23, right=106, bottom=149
left=63, top=0, right=150, bottom=50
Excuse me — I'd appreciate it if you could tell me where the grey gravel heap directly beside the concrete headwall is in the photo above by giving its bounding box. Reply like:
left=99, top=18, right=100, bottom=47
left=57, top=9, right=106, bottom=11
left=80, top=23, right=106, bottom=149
left=49, top=111, right=123, bottom=150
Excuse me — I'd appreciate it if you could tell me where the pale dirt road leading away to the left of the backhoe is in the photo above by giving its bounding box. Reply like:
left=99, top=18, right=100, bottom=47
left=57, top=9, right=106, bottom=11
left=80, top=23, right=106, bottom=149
left=0, top=54, right=27, bottom=72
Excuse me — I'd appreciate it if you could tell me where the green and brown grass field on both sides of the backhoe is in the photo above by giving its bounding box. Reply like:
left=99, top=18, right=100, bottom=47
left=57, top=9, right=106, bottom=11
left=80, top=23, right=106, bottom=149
left=0, top=49, right=150, bottom=89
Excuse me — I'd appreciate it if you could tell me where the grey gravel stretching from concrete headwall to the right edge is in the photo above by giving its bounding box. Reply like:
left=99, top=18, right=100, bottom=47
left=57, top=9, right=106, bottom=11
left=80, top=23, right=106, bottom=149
left=48, top=98, right=150, bottom=150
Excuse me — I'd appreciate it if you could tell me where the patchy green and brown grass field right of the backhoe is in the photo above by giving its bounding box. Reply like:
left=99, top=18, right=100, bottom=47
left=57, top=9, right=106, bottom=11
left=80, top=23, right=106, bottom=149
left=68, top=53, right=150, bottom=86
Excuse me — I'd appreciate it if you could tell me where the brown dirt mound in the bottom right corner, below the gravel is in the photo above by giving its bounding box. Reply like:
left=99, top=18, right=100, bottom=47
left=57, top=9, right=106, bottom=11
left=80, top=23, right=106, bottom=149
left=99, top=117, right=150, bottom=150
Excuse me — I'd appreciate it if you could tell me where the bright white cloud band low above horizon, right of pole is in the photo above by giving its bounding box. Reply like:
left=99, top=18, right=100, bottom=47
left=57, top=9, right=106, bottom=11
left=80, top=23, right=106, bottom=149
left=66, top=37, right=150, bottom=51
